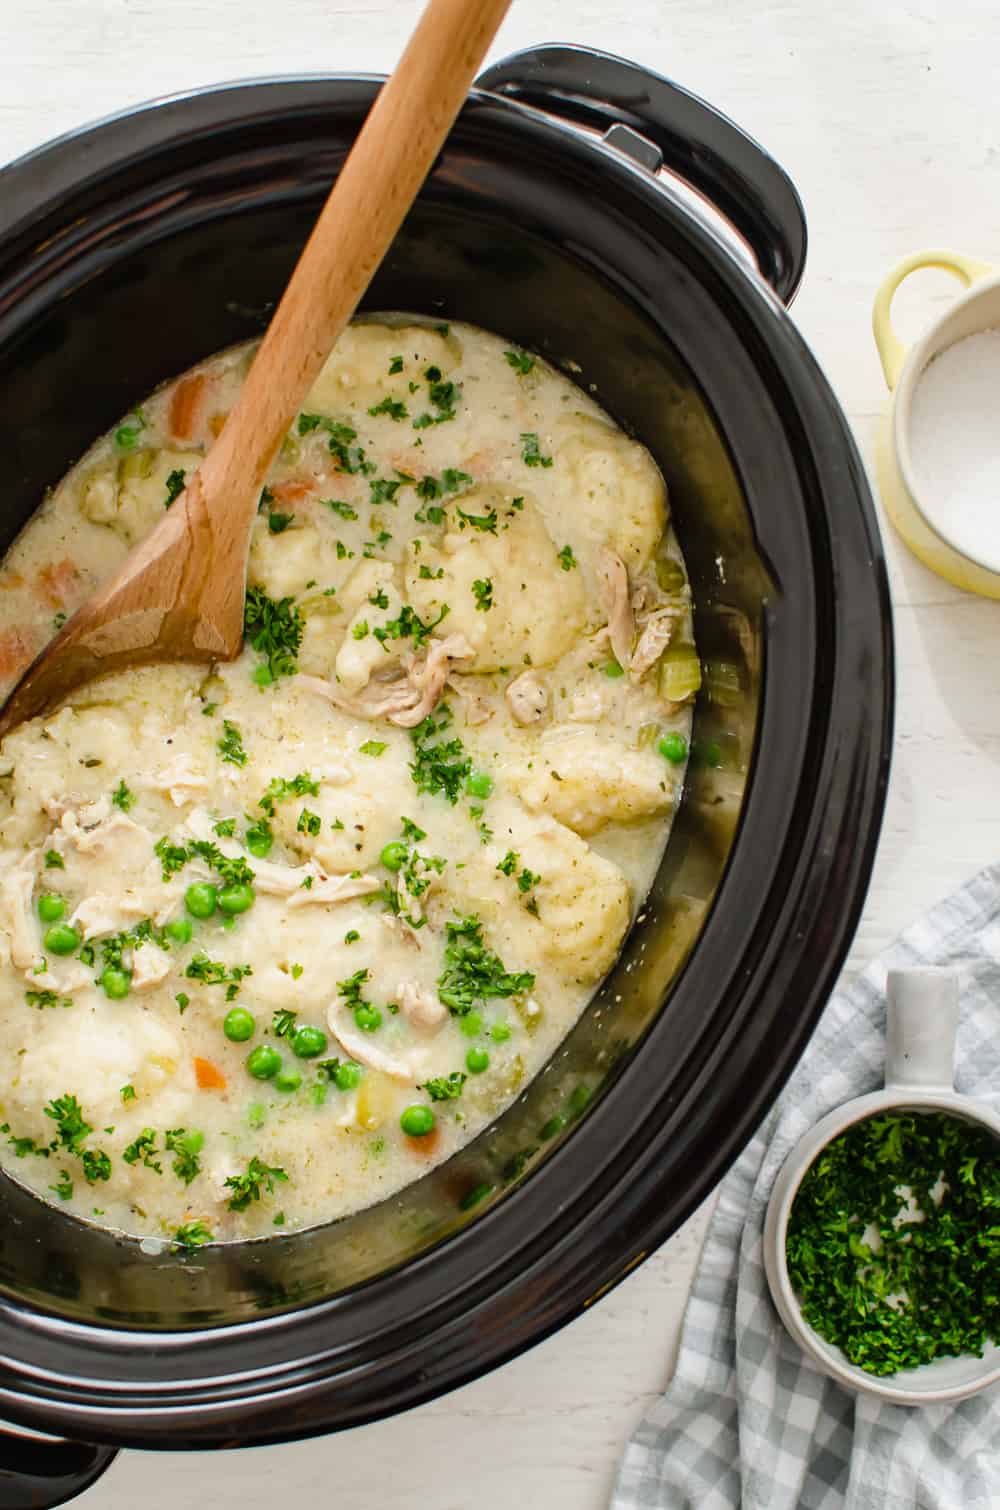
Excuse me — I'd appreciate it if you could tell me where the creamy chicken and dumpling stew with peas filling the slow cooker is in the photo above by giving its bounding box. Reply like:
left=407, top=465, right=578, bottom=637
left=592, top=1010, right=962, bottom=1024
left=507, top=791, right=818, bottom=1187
left=0, top=316, right=699, bottom=1246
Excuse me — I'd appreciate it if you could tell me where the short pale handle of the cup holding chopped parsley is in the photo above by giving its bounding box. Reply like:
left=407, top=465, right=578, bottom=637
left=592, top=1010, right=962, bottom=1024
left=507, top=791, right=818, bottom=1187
left=885, top=965, right=958, bottom=1090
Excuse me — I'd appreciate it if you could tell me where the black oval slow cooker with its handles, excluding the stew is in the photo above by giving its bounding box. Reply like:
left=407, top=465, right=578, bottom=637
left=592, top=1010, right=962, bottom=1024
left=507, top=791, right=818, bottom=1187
left=0, top=47, right=891, bottom=1510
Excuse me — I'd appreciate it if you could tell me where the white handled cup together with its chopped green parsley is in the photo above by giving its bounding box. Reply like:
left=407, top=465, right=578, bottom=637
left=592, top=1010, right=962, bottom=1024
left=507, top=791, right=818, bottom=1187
left=764, top=969, right=1000, bottom=1404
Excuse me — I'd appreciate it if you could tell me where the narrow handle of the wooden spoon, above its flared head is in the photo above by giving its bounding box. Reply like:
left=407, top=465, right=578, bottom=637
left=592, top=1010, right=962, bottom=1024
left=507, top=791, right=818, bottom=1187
left=201, top=0, right=511, bottom=548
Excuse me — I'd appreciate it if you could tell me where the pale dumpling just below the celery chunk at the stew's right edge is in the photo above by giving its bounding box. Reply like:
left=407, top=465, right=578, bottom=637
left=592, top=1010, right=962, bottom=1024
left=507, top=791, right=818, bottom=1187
left=506, top=728, right=674, bottom=835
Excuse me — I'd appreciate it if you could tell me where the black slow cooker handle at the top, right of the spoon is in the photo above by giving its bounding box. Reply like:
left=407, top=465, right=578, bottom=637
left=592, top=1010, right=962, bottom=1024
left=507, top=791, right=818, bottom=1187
left=476, top=42, right=807, bottom=304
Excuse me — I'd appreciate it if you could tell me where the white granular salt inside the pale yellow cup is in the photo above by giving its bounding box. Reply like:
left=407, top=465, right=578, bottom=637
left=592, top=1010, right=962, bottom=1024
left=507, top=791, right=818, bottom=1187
left=909, top=331, right=1000, bottom=560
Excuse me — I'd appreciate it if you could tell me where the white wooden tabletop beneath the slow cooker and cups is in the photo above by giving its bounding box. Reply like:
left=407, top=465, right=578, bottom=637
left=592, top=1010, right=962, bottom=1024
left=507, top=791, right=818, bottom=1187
left=0, top=0, right=1000, bottom=1510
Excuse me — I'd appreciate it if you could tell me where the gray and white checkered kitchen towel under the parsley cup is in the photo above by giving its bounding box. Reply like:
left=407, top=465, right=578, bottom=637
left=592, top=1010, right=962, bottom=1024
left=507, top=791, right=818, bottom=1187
left=613, top=865, right=1000, bottom=1510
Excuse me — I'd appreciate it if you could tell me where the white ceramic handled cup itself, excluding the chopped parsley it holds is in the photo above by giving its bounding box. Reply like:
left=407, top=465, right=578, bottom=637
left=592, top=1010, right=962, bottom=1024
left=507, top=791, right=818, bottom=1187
left=764, top=968, right=1000, bottom=1406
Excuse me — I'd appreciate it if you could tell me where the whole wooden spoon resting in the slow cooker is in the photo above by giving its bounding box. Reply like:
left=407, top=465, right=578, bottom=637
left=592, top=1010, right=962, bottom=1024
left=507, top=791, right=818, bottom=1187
left=0, top=0, right=511, bottom=735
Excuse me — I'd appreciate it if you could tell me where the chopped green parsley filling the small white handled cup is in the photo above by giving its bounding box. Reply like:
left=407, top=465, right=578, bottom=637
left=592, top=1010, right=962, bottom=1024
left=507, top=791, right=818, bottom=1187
left=785, top=1111, right=1000, bottom=1376
